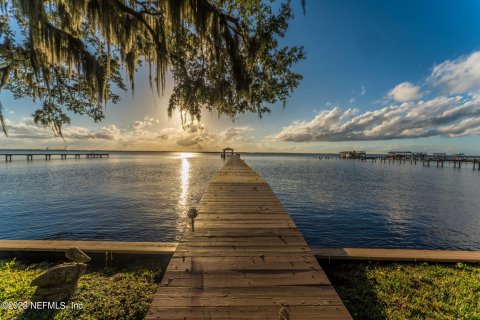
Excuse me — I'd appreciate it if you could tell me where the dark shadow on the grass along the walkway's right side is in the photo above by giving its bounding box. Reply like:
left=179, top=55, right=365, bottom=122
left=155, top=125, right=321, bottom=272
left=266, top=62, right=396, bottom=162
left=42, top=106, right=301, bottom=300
left=319, top=260, right=387, bottom=320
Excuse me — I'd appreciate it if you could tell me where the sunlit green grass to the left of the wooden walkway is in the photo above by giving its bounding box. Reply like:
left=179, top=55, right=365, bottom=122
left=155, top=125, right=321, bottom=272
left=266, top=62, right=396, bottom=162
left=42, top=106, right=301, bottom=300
left=0, top=260, right=162, bottom=320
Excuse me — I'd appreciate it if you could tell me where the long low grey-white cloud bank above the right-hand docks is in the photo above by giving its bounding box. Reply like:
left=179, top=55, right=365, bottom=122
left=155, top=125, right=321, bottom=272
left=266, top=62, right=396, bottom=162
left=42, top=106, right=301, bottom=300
left=275, top=95, right=480, bottom=142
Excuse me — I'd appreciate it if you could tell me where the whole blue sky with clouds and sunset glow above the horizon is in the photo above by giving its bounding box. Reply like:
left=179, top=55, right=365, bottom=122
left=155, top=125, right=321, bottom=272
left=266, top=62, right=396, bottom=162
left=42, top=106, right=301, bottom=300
left=0, top=0, right=480, bottom=154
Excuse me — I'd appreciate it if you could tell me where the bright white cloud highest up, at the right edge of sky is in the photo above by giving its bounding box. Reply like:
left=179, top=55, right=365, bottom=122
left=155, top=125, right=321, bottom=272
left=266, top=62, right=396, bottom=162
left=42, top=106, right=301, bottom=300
left=428, top=51, right=480, bottom=94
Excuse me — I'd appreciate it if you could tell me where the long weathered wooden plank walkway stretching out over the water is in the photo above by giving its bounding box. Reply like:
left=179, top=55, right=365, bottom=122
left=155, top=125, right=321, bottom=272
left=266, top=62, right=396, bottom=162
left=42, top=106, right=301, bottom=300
left=146, top=156, right=351, bottom=320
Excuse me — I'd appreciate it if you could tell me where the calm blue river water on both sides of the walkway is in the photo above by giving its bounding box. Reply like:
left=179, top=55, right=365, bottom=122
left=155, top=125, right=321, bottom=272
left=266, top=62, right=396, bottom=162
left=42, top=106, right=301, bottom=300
left=0, top=153, right=480, bottom=250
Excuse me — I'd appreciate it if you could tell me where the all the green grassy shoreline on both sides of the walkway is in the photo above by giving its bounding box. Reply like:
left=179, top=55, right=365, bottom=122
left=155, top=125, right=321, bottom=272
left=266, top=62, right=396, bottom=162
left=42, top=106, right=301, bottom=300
left=0, top=260, right=480, bottom=320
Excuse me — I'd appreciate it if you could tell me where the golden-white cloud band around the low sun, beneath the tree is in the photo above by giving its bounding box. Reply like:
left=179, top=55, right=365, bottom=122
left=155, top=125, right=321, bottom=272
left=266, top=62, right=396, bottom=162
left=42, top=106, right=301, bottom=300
left=2, top=117, right=253, bottom=151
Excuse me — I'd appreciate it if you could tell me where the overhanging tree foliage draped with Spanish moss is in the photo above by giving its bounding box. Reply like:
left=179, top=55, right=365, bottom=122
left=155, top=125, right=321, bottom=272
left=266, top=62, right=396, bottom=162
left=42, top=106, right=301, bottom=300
left=0, top=0, right=304, bottom=135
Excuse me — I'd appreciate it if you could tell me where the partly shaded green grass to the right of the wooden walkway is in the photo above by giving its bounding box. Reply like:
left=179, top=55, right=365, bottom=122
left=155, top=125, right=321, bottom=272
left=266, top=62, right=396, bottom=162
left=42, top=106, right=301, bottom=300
left=321, top=261, right=480, bottom=319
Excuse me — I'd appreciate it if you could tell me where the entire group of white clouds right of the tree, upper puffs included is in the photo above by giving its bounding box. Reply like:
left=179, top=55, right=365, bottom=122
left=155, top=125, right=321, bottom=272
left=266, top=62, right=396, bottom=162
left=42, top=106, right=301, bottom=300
left=274, top=51, right=480, bottom=142
